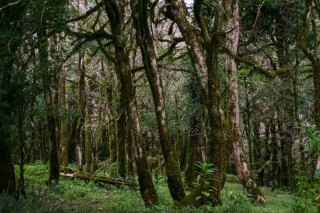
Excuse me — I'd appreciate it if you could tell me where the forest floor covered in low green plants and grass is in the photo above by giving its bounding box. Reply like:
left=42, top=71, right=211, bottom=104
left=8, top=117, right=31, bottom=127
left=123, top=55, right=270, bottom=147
left=0, top=163, right=320, bottom=213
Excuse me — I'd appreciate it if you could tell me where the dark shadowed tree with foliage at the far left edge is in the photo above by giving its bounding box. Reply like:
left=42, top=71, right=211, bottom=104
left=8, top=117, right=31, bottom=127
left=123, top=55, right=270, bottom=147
left=0, top=1, right=26, bottom=195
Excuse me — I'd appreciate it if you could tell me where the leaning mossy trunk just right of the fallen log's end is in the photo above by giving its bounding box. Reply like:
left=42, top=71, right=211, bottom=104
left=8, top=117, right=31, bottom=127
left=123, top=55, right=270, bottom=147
left=104, top=0, right=159, bottom=207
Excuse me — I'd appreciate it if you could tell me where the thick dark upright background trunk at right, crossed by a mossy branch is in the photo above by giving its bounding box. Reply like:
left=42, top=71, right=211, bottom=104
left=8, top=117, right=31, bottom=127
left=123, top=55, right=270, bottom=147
left=275, top=9, right=297, bottom=191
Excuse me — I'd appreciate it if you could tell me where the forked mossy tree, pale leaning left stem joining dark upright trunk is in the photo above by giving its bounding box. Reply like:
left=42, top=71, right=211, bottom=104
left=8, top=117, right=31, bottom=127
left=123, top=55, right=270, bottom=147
left=166, top=0, right=228, bottom=206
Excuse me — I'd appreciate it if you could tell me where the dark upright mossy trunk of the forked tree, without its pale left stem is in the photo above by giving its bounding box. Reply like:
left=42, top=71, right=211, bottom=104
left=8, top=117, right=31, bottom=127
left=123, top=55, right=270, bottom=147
left=206, top=10, right=225, bottom=205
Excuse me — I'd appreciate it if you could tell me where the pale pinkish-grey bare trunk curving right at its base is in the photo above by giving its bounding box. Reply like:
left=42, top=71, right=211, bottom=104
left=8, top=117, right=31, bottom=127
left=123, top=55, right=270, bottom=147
left=226, top=0, right=265, bottom=203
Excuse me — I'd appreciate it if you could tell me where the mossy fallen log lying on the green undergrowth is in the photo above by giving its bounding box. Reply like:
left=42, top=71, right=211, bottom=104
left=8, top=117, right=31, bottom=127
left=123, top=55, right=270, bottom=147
left=60, top=170, right=139, bottom=189
